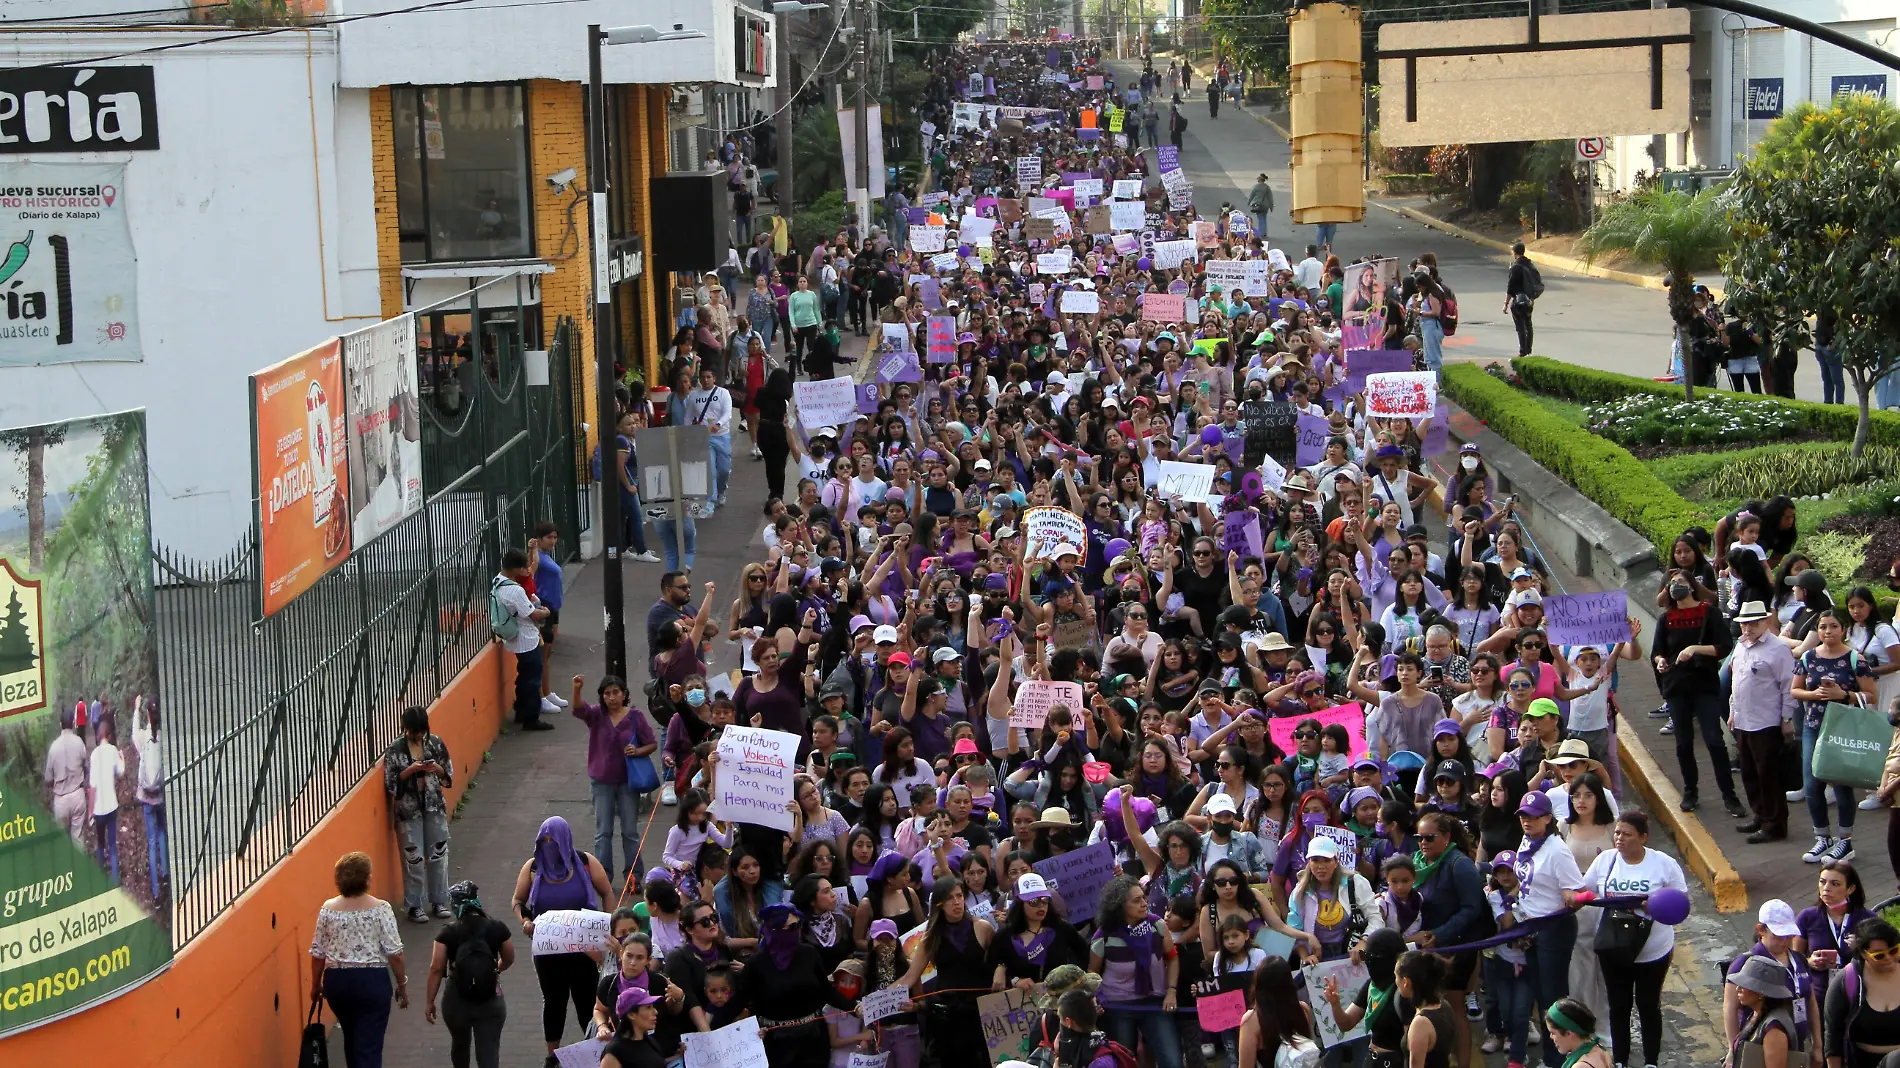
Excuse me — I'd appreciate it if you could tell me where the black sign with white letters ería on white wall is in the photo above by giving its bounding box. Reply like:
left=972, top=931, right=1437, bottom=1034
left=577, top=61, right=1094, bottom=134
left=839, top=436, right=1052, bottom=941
left=0, top=67, right=158, bottom=154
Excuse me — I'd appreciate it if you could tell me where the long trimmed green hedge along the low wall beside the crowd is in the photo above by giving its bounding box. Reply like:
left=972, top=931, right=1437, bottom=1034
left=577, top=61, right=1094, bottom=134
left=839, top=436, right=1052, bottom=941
left=1440, top=359, right=1717, bottom=559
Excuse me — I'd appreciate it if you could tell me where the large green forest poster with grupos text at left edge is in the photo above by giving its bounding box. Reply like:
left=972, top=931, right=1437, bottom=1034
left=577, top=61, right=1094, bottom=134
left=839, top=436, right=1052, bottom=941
left=0, top=412, right=171, bottom=1039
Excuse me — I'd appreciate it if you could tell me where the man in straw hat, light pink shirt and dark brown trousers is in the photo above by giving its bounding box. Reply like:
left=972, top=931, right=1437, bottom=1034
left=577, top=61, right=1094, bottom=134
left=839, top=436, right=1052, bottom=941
left=1725, top=600, right=1799, bottom=842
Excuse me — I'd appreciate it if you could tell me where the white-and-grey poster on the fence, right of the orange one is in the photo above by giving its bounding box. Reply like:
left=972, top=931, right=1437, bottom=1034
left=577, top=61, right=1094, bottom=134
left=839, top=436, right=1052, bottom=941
left=342, top=315, right=422, bottom=547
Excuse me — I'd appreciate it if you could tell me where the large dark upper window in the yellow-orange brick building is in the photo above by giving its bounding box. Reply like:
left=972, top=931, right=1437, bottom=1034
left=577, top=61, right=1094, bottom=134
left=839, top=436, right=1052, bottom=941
left=390, top=86, right=534, bottom=262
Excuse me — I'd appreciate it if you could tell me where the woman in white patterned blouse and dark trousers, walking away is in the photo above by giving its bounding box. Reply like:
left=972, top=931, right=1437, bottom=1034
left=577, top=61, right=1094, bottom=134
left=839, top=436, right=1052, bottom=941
left=310, top=853, right=409, bottom=1068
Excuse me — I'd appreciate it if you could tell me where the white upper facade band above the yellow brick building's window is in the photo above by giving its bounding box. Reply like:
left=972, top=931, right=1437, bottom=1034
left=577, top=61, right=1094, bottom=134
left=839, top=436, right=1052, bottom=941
left=331, top=0, right=777, bottom=89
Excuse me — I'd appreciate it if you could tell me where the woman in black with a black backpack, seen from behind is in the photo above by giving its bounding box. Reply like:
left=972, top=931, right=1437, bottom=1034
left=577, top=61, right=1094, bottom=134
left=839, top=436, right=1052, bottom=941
left=422, top=880, right=515, bottom=1068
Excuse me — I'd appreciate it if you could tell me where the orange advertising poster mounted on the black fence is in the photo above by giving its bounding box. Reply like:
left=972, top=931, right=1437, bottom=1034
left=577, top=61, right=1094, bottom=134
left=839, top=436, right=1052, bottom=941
left=251, top=338, right=350, bottom=616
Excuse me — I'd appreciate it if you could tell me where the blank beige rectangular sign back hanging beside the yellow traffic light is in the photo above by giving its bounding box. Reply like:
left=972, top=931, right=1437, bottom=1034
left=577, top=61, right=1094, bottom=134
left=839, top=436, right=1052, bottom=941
left=1378, top=8, right=1689, bottom=148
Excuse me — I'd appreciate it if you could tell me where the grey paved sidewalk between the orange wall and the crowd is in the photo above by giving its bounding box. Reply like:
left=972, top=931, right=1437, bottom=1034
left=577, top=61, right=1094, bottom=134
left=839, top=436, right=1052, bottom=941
left=378, top=421, right=766, bottom=1068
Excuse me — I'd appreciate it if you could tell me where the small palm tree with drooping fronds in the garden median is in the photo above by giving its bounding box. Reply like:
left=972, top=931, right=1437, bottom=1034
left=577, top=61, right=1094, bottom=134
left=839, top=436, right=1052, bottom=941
left=1577, top=188, right=1733, bottom=401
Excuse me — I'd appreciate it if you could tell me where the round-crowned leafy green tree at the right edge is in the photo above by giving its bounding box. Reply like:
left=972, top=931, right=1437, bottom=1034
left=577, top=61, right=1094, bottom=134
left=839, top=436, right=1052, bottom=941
left=1723, top=93, right=1900, bottom=456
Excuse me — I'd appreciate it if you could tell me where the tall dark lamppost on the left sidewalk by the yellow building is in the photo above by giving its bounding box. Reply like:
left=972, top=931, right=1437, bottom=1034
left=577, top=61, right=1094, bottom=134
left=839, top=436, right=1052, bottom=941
left=587, top=25, right=627, bottom=678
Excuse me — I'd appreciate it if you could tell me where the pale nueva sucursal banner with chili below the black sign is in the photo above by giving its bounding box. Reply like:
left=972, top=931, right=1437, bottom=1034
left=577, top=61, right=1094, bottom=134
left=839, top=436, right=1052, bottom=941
left=0, top=161, right=144, bottom=367
